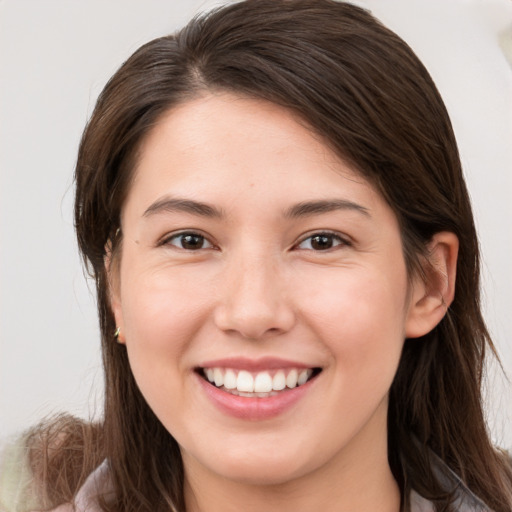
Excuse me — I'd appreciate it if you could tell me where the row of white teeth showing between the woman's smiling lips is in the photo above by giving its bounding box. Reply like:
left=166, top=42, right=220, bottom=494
left=197, top=367, right=322, bottom=398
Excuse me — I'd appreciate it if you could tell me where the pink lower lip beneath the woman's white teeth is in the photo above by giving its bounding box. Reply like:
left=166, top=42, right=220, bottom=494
left=196, top=374, right=316, bottom=421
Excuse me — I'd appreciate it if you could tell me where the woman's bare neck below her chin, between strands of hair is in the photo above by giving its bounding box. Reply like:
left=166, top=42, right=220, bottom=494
left=184, top=408, right=400, bottom=512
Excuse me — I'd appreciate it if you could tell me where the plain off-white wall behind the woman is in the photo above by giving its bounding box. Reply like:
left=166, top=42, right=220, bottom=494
left=0, top=0, right=512, bottom=447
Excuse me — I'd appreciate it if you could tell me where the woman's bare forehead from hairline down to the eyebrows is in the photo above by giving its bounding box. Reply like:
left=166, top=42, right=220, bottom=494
left=128, top=93, right=390, bottom=220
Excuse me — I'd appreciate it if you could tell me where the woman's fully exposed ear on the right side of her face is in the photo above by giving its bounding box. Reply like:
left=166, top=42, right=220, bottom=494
left=405, top=231, right=459, bottom=338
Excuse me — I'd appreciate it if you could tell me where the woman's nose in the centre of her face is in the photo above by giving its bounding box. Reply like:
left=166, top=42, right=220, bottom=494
left=214, top=255, right=295, bottom=340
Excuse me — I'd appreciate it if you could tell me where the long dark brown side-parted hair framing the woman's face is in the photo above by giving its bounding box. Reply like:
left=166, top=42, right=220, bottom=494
left=35, top=0, right=512, bottom=512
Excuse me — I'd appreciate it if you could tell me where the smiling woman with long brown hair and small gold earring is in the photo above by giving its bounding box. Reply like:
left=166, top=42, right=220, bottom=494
left=2, top=0, right=512, bottom=512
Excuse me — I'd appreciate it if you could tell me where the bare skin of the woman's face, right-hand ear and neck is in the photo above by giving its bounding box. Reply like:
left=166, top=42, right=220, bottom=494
left=112, top=94, right=457, bottom=512
